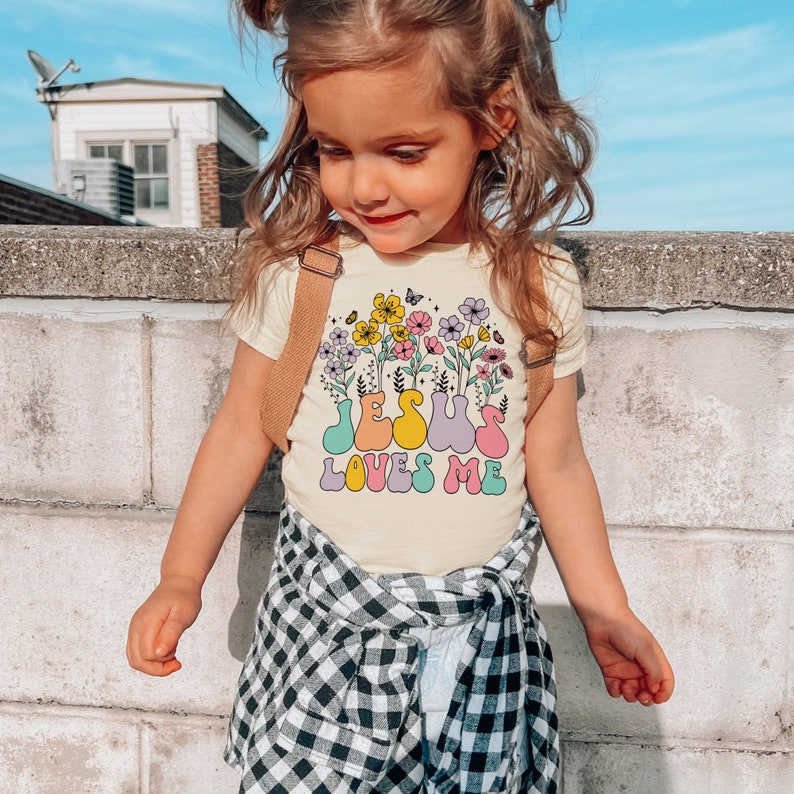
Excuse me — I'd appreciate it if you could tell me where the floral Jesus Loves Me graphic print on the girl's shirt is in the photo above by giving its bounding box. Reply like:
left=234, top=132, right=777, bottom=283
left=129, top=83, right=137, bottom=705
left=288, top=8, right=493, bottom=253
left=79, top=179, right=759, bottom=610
left=318, top=288, right=513, bottom=496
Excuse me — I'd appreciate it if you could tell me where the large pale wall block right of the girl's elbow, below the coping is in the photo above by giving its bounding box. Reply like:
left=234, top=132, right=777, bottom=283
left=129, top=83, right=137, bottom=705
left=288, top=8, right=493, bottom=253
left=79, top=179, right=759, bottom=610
left=580, top=328, right=794, bottom=530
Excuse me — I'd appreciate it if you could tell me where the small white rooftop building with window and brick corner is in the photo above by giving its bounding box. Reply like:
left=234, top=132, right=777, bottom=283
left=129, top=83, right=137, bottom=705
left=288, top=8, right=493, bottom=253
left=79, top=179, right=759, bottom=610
left=38, top=77, right=267, bottom=227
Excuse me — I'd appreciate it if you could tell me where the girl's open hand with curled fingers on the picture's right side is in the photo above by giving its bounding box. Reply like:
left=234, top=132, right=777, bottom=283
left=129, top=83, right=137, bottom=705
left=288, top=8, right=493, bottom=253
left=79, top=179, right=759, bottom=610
left=582, top=610, right=674, bottom=706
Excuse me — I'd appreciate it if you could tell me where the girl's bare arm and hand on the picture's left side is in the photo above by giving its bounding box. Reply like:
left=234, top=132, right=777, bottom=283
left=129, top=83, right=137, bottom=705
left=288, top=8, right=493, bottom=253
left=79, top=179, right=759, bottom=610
left=127, top=342, right=274, bottom=676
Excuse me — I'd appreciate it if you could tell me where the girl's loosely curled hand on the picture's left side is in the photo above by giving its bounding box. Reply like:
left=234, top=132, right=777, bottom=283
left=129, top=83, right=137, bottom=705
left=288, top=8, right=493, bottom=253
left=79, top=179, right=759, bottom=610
left=127, top=576, right=201, bottom=676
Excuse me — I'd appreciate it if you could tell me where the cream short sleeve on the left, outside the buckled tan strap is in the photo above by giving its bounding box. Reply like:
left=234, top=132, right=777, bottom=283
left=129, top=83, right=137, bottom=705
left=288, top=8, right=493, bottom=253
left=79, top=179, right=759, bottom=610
left=229, top=265, right=298, bottom=359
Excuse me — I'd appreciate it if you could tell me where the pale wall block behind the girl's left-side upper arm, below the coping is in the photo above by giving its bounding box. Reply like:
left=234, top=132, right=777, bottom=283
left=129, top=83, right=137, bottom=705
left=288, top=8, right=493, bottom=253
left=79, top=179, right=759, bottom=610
left=152, top=320, right=283, bottom=512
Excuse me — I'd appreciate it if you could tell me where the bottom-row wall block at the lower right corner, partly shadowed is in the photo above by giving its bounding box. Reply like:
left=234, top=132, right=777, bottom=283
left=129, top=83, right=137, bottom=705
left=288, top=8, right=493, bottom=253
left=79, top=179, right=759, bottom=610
left=563, top=741, right=794, bottom=794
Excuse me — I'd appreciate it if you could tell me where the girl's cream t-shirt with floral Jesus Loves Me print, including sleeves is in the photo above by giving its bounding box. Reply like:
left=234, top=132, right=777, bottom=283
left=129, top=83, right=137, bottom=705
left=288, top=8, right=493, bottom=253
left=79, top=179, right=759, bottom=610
left=232, top=239, right=586, bottom=575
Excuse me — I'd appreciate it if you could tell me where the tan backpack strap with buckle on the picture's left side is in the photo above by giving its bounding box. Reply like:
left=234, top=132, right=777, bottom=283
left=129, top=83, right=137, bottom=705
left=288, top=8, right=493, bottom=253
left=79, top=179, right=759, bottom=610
left=259, top=237, right=343, bottom=452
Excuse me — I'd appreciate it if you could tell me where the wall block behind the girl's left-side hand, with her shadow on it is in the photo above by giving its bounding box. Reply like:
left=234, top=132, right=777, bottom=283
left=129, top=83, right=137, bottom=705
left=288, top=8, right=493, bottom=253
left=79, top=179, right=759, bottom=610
left=0, top=508, right=273, bottom=716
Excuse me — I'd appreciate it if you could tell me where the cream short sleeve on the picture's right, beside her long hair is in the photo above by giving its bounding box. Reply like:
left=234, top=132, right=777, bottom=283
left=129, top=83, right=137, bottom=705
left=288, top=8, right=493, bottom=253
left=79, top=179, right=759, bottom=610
left=543, top=247, right=587, bottom=378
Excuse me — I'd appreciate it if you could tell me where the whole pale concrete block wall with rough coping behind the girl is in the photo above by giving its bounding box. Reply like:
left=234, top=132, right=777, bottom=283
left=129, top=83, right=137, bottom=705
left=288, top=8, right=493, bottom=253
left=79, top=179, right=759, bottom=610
left=0, top=227, right=794, bottom=794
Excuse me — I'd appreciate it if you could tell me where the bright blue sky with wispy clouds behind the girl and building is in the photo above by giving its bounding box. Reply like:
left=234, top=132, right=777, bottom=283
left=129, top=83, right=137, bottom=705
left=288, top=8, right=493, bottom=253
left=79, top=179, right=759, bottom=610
left=0, top=0, right=794, bottom=231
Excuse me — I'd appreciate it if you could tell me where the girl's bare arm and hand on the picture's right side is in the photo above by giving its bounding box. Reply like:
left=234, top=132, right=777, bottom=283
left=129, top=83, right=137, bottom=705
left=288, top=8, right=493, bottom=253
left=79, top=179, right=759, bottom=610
left=525, top=375, right=673, bottom=706
